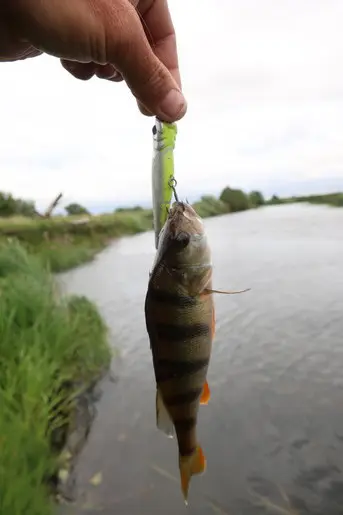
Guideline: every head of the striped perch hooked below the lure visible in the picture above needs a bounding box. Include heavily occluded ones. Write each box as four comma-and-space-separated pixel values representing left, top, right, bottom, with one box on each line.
159, 202, 211, 268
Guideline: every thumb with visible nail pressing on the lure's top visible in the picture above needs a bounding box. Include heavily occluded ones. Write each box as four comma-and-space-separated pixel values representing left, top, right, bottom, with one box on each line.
105, 0, 187, 122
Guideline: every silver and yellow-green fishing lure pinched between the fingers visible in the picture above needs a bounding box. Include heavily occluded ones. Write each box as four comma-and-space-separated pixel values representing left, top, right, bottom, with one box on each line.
152, 118, 177, 249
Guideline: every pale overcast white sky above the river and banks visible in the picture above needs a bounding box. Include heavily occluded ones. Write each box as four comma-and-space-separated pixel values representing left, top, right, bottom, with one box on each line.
0, 0, 343, 214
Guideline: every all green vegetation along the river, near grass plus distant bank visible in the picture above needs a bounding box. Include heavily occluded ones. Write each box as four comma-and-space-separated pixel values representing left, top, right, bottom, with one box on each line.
0, 188, 343, 515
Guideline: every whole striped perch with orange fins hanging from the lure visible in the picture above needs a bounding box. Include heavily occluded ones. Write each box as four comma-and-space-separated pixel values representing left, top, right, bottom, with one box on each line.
145, 201, 250, 504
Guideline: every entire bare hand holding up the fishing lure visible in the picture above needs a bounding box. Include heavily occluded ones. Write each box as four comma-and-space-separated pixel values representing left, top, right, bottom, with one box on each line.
0, 0, 187, 122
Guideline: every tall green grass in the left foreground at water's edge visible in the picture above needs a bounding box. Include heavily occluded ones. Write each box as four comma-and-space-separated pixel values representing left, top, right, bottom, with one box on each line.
0, 242, 110, 515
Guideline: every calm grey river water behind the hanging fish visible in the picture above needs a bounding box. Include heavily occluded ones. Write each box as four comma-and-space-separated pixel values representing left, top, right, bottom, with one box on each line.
57, 205, 343, 515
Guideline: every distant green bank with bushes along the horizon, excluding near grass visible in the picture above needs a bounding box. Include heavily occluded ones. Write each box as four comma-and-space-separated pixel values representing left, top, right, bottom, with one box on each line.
0, 187, 343, 272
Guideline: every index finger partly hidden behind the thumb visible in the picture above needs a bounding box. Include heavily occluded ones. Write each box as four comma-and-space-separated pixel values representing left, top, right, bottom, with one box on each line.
137, 0, 181, 89
